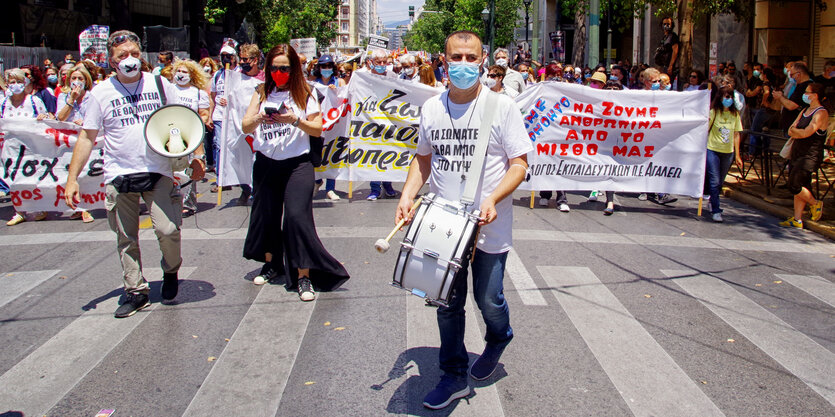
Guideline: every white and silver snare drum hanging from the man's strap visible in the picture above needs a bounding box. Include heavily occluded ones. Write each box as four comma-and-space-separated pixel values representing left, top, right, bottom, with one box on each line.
392, 193, 480, 306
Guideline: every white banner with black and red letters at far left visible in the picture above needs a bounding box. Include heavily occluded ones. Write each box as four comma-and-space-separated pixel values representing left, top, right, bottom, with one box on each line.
0, 118, 104, 212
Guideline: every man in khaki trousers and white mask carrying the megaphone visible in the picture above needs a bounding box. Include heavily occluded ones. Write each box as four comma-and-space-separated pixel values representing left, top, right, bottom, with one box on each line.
65, 30, 205, 318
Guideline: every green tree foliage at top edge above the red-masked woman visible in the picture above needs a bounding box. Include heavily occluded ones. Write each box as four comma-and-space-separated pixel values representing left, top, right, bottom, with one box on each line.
205, 0, 342, 48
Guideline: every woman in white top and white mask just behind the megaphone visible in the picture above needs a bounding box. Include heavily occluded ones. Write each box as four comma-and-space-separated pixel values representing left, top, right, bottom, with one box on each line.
160, 59, 214, 217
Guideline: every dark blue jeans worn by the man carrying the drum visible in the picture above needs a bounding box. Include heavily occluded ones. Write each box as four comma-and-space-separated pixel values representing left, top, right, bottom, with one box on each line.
438, 250, 513, 378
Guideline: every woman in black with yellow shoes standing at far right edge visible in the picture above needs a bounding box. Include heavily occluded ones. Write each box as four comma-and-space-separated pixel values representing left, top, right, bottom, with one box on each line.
780, 83, 830, 228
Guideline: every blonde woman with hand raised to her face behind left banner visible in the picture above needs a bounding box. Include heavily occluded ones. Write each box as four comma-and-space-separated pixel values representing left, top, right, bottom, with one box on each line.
55, 64, 93, 223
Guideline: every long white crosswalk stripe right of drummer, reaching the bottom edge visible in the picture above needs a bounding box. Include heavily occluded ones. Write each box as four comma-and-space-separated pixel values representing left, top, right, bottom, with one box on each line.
538, 266, 724, 417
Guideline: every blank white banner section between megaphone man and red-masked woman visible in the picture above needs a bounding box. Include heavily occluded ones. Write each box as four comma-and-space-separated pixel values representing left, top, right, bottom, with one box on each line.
215, 70, 258, 187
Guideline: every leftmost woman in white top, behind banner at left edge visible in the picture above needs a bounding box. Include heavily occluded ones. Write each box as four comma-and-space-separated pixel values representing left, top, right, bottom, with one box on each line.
0, 68, 51, 226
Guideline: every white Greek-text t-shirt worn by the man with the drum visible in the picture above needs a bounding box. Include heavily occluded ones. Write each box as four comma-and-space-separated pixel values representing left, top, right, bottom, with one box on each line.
417, 87, 533, 253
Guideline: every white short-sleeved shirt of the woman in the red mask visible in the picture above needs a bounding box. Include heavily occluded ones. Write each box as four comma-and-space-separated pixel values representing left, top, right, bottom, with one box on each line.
252, 91, 319, 161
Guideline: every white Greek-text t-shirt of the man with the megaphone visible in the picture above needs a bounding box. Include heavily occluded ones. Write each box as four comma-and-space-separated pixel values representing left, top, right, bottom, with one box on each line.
84, 72, 180, 183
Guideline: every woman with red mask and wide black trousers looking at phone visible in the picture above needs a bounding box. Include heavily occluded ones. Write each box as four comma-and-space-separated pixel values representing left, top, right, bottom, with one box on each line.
242, 44, 350, 301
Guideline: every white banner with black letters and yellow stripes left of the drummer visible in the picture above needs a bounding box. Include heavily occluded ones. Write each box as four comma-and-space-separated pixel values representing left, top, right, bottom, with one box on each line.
317, 72, 440, 181
